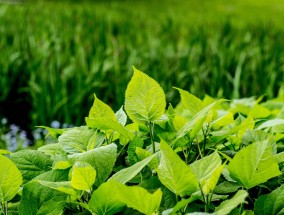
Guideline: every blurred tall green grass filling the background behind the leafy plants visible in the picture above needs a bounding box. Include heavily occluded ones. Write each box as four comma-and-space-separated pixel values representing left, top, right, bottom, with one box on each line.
0, 0, 284, 133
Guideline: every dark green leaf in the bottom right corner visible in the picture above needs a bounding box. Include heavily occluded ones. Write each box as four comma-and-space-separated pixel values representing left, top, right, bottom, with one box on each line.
254, 185, 284, 215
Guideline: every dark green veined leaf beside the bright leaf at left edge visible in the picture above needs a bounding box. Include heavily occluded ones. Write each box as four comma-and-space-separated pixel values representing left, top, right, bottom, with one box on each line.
11, 149, 53, 184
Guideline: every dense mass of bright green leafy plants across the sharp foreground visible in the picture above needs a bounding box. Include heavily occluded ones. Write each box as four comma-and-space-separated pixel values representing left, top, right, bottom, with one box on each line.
0, 68, 284, 215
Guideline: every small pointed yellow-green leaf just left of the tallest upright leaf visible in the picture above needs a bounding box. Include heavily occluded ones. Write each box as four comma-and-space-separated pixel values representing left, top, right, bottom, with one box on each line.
88, 95, 116, 120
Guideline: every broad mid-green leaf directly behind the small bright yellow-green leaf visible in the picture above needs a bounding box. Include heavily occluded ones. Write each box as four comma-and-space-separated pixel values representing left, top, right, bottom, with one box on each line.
68, 143, 117, 186
